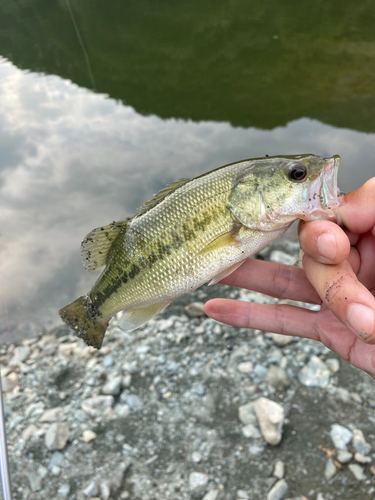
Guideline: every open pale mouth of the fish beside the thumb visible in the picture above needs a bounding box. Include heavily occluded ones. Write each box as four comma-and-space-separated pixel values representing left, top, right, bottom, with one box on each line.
309, 155, 342, 220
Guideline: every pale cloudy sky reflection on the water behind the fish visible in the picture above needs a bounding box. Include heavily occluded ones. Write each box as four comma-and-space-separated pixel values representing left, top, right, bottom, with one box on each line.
0, 60, 375, 341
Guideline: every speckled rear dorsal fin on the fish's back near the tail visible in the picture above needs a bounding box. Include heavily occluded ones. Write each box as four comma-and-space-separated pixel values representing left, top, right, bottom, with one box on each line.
81, 219, 130, 271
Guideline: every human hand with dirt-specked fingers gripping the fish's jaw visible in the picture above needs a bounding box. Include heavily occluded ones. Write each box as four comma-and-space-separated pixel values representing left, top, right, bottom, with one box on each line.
205, 178, 375, 378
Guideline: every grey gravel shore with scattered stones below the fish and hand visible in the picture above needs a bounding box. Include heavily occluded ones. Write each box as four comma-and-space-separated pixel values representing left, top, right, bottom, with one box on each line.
0, 241, 375, 500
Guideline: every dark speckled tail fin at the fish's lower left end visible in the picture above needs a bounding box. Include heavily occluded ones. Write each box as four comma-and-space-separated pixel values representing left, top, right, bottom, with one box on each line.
59, 297, 108, 349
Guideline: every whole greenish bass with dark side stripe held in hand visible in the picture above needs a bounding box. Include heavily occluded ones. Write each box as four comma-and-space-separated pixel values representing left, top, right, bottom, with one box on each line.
59, 154, 340, 349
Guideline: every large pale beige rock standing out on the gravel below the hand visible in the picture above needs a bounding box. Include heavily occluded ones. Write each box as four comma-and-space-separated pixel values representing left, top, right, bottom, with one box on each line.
255, 398, 284, 446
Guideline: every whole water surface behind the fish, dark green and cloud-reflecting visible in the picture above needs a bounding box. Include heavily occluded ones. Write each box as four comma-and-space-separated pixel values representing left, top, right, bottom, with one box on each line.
0, 0, 375, 340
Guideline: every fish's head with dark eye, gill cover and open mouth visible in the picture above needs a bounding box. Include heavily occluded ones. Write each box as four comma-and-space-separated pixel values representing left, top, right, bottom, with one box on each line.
229, 154, 341, 231
